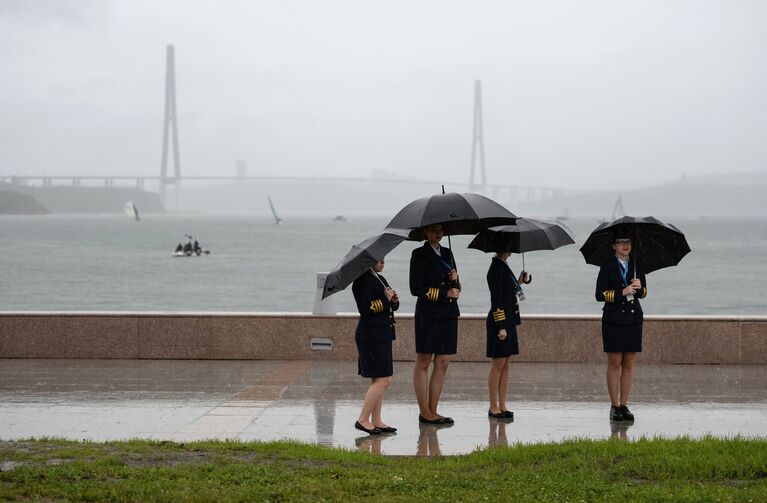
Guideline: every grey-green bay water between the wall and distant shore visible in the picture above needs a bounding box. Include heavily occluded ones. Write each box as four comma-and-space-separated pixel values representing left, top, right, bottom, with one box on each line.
0, 213, 767, 315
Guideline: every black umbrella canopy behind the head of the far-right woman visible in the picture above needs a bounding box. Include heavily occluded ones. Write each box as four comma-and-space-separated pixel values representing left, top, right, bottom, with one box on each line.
581, 216, 690, 273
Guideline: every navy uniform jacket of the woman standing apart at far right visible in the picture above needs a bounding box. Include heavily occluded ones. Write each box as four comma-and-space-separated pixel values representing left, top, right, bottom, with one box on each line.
595, 257, 647, 325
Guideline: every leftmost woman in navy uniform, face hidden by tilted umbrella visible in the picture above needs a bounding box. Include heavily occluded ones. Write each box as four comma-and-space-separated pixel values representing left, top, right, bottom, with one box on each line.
352, 259, 399, 435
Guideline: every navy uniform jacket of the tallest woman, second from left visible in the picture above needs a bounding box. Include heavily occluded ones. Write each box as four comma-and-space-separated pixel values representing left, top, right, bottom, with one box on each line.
410, 241, 461, 319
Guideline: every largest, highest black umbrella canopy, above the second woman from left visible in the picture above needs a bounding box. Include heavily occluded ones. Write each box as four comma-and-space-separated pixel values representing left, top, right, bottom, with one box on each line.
387, 192, 517, 241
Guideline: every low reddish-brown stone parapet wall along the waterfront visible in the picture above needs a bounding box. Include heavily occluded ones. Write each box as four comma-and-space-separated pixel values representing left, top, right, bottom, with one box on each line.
0, 312, 767, 364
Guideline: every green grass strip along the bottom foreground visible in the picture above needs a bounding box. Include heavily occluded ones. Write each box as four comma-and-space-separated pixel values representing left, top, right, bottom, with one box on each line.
0, 438, 767, 502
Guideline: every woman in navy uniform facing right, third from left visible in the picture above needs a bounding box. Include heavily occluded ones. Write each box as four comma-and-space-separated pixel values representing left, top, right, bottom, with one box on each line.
485, 252, 529, 419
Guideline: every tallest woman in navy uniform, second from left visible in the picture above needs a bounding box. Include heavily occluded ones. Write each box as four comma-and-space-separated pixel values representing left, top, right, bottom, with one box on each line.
410, 224, 461, 424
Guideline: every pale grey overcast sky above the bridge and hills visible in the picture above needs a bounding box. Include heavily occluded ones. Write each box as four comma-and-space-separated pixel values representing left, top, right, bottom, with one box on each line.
0, 0, 767, 188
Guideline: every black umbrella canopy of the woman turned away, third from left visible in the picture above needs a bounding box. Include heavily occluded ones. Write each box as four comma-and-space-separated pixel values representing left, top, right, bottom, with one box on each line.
469, 218, 575, 253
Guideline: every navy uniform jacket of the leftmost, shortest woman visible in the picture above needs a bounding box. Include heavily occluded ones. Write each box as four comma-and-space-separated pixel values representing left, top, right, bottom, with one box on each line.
352, 270, 399, 342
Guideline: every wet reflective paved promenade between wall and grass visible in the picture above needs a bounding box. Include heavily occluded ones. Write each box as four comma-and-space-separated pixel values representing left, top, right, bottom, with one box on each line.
0, 360, 767, 455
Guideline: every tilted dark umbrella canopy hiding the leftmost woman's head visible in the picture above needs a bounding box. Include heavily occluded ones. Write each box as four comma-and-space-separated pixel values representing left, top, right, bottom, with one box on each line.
322, 229, 410, 299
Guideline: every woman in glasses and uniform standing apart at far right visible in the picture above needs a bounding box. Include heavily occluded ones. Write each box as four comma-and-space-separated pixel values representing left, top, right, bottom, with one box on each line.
595, 237, 647, 421
